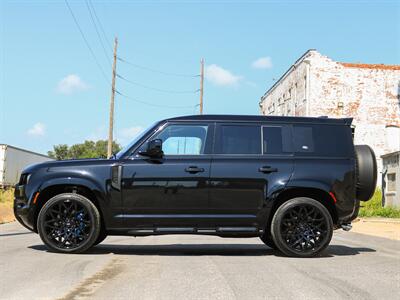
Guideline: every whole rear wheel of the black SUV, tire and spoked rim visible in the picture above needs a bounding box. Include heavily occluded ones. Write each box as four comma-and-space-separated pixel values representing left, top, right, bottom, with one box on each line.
271, 197, 333, 257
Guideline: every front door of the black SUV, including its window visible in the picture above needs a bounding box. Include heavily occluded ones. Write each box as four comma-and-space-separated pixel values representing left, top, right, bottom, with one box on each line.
122, 123, 213, 228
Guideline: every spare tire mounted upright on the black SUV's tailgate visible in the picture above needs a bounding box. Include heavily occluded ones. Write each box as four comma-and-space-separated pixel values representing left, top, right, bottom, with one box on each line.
354, 145, 378, 201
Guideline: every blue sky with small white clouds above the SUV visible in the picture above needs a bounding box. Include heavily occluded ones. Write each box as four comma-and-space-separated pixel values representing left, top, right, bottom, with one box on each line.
0, 0, 400, 153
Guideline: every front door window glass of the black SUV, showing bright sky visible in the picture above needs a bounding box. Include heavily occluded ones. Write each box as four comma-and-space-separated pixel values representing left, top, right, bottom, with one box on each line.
153, 125, 208, 155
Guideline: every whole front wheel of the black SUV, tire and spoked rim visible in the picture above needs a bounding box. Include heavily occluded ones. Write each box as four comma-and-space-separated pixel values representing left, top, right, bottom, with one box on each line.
37, 193, 101, 253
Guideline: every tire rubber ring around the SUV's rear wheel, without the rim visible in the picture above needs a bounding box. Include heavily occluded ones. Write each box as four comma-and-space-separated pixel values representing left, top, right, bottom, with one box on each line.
271, 197, 333, 257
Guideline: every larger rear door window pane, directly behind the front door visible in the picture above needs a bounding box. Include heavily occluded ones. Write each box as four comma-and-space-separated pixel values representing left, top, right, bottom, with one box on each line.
216, 125, 261, 154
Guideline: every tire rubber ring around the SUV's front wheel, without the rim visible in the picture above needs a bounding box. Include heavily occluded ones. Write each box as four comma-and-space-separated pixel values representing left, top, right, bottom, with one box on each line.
37, 193, 101, 253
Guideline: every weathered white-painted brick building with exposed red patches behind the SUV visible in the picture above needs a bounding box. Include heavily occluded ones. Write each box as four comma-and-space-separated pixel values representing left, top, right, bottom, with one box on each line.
260, 50, 400, 183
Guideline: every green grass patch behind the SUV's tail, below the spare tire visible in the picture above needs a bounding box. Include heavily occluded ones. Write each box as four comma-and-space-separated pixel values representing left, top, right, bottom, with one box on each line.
358, 189, 400, 218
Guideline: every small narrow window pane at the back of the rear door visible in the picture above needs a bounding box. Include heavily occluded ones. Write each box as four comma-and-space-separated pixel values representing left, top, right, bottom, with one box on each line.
262, 125, 291, 154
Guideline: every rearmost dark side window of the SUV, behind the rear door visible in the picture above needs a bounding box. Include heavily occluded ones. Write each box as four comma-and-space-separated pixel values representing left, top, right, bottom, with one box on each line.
293, 125, 353, 157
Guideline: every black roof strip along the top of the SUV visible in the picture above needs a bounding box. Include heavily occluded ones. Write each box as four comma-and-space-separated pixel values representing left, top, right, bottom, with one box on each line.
167, 115, 353, 125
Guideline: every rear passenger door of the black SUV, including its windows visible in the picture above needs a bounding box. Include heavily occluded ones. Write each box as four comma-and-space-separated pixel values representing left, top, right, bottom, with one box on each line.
210, 123, 293, 227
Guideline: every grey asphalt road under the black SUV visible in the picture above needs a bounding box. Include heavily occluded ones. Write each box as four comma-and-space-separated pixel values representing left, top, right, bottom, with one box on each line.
0, 222, 400, 300
